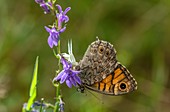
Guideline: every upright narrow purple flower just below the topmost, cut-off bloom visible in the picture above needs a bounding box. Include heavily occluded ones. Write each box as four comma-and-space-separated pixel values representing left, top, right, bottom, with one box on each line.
56, 4, 71, 29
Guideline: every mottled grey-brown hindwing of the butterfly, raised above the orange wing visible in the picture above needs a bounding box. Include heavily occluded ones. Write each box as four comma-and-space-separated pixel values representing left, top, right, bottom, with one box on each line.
77, 40, 117, 85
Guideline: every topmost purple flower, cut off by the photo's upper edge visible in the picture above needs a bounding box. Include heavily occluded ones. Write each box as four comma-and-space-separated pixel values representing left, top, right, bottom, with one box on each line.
35, 0, 52, 14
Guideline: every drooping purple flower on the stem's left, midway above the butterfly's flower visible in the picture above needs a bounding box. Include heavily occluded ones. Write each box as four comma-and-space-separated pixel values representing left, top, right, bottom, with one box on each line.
45, 26, 66, 48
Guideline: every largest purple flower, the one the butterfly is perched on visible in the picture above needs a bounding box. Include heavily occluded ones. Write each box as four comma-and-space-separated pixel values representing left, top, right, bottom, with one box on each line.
53, 57, 81, 88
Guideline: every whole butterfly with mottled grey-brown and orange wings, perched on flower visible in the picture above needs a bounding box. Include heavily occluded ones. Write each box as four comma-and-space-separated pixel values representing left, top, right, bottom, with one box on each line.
76, 39, 137, 95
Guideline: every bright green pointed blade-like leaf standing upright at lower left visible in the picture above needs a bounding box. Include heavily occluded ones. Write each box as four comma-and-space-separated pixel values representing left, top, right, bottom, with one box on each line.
26, 56, 39, 111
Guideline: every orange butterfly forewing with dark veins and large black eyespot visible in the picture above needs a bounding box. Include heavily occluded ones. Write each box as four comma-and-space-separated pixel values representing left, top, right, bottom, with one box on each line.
85, 63, 137, 95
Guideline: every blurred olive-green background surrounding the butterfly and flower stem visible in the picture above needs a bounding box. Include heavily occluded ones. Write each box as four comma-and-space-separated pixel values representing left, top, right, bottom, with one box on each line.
0, 0, 170, 112
